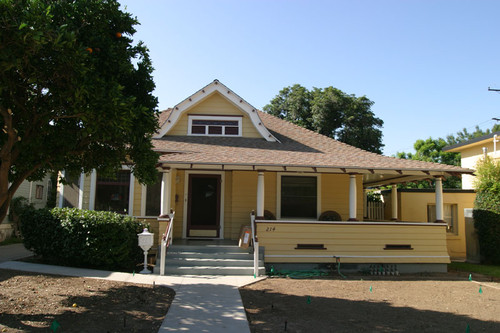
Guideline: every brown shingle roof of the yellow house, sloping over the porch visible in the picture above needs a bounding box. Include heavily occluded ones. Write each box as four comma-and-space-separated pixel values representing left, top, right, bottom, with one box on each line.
153, 109, 472, 173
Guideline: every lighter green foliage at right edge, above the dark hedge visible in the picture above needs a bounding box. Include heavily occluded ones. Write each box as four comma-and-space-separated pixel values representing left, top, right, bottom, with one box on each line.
474, 157, 500, 214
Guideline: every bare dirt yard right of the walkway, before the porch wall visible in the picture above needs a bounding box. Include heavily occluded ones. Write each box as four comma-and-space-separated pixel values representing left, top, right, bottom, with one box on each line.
240, 275, 500, 333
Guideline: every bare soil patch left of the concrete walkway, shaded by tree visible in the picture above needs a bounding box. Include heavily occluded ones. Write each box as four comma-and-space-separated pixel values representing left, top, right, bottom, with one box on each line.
0, 269, 175, 333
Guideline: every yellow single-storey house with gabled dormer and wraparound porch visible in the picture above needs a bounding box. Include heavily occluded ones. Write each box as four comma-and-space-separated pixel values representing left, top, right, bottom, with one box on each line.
59, 80, 472, 271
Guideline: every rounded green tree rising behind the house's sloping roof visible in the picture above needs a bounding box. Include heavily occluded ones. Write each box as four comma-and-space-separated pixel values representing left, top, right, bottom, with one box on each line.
264, 84, 384, 154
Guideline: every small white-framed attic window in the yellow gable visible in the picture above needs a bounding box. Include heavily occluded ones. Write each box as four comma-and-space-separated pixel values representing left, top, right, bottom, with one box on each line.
188, 116, 241, 136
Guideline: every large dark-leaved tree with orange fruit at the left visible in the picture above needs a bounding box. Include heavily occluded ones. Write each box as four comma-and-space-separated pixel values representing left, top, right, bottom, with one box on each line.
0, 0, 158, 221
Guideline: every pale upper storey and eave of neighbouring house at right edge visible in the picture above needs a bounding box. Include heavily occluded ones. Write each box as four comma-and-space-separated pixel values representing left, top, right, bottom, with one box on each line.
443, 132, 500, 190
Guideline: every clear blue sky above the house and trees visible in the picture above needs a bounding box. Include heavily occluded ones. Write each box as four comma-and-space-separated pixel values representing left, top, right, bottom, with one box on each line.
120, 0, 500, 155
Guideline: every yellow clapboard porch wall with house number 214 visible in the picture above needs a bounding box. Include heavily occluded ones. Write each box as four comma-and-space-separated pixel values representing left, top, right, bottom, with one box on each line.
256, 220, 450, 264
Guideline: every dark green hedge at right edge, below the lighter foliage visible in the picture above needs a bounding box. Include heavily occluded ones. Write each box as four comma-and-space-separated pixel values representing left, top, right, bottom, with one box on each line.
473, 209, 500, 264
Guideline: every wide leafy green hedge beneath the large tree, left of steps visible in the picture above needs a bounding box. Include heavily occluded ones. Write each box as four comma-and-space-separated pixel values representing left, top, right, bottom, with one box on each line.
20, 208, 146, 270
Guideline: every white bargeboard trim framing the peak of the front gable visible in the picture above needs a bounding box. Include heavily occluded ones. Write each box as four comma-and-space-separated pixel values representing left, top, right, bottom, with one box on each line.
155, 80, 277, 142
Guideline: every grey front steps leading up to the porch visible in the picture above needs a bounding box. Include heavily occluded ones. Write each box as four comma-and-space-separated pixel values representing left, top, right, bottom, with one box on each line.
154, 241, 266, 276
